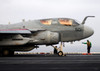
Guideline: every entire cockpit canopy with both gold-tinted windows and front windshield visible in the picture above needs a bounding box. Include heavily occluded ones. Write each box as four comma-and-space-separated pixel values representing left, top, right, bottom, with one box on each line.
40, 18, 79, 26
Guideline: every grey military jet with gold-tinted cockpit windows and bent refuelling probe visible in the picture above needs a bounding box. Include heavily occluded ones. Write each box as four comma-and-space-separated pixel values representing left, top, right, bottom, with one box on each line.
0, 16, 94, 56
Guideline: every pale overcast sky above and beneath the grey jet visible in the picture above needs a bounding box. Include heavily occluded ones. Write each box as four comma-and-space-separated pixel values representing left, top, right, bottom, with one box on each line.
0, 0, 100, 52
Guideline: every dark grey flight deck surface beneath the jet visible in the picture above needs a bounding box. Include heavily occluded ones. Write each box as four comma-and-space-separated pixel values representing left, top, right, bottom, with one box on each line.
0, 54, 100, 71
